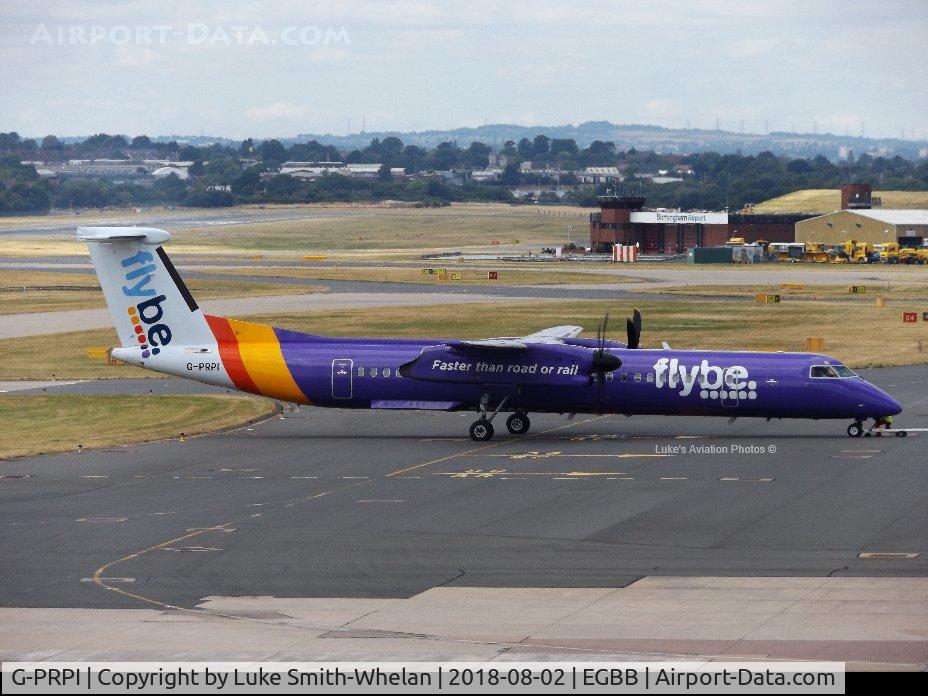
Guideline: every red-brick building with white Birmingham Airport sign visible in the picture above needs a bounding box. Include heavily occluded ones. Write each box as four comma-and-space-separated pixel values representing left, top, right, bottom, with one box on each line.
590, 195, 811, 254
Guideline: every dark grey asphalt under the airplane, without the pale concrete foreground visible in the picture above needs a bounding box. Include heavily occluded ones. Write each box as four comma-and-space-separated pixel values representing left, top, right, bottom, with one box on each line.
0, 367, 928, 607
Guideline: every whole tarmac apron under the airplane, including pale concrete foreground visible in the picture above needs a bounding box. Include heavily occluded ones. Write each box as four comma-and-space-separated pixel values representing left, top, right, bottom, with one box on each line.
0, 366, 928, 669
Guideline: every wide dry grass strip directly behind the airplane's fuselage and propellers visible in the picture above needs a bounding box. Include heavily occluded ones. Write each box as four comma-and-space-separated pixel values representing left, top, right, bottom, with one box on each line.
0, 296, 928, 380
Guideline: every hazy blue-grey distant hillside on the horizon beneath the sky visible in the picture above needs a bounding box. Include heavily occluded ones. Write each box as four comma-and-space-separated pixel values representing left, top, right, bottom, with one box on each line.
284, 121, 928, 160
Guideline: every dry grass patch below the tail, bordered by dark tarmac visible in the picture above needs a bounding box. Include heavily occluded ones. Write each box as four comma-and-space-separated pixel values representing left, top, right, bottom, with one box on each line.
0, 394, 274, 459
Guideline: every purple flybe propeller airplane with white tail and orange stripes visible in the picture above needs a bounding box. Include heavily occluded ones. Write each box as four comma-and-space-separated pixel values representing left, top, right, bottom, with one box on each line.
83, 227, 902, 441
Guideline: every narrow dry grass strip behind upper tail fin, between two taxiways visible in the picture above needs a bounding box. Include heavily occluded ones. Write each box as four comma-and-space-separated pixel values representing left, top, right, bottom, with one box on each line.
0, 271, 325, 314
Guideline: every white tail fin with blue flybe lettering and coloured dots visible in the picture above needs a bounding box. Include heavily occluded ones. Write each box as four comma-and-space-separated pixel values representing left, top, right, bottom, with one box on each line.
77, 227, 215, 358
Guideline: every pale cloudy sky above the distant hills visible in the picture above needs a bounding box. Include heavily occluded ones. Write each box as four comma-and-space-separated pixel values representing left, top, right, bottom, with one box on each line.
0, 0, 928, 138
